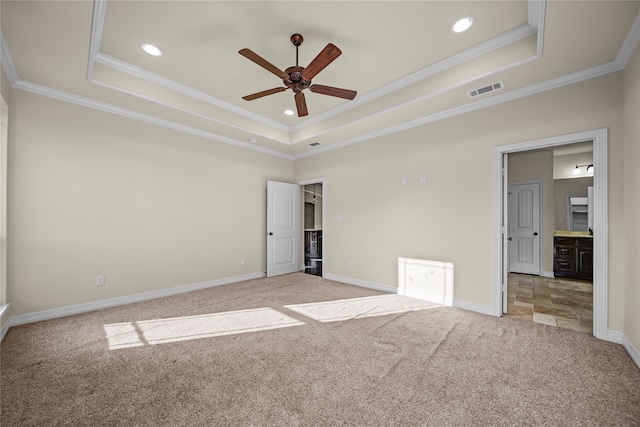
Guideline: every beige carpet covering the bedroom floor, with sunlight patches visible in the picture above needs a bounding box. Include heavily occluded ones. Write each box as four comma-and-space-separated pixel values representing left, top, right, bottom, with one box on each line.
0, 273, 640, 427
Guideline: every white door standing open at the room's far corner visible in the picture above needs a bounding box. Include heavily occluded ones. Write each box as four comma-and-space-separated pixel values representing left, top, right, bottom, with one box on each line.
267, 181, 300, 277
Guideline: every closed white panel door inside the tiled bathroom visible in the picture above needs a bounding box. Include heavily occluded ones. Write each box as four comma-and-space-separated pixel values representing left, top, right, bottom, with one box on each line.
508, 183, 540, 275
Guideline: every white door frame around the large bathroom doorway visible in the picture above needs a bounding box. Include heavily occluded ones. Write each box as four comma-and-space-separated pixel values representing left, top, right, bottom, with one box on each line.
493, 128, 609, 340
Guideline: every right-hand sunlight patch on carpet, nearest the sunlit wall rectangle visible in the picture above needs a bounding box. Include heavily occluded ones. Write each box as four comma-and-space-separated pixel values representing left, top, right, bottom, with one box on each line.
285, 295, 442, 322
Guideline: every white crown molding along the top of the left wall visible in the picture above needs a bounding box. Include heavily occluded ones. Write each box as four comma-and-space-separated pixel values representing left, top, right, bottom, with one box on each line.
13, 80, 293, 160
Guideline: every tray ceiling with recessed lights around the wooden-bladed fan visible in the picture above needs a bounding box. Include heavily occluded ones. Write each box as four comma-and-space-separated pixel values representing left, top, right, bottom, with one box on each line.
0, 0, 640, 158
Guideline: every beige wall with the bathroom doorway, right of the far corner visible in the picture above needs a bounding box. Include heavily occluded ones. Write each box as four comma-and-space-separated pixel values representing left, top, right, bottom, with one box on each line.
295, 73, 624, 331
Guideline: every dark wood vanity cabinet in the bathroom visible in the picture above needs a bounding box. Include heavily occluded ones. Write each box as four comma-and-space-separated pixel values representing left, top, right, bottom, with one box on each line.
553, 236, 593, 280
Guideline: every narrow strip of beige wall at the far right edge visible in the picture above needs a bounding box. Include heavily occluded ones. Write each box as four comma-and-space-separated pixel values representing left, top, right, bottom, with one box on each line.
621, 48, 640, 351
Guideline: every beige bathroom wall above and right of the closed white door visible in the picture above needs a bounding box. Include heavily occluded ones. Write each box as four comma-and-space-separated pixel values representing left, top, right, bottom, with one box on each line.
508, 150, 555, 276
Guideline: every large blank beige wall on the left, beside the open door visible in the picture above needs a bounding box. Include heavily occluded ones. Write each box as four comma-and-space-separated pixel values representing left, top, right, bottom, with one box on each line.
7, 91, 293, 315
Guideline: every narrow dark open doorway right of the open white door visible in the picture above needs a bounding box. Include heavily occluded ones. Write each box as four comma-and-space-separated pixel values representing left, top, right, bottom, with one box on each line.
302, 182, 324, 276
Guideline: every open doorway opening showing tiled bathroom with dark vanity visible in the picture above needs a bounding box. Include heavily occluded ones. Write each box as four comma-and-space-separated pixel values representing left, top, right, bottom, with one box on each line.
503, 145, 593, 334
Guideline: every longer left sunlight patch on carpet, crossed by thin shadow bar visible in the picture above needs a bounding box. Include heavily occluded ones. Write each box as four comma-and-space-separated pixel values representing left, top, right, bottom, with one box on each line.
104, 308, 304, 350
